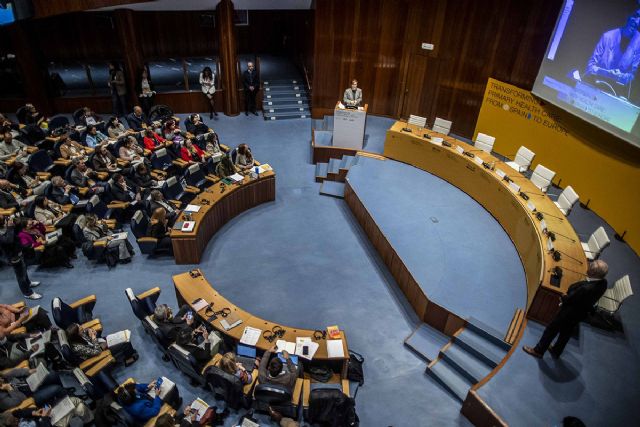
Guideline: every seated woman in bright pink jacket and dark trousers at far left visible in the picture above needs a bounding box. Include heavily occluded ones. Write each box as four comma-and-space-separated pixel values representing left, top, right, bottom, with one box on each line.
16, 218, 76, 268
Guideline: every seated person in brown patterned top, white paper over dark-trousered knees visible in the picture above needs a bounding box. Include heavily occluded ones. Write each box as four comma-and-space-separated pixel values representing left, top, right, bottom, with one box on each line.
66, 323, 138, 366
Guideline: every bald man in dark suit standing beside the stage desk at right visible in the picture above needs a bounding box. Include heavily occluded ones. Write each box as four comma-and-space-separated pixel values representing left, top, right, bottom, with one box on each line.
522, 260, 609, 359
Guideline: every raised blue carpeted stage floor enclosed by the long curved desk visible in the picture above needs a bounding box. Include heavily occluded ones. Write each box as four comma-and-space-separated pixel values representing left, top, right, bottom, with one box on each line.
347, 157, 527, 335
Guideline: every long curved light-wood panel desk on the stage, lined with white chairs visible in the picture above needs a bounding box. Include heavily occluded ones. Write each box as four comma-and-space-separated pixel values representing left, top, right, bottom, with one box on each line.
370, 121, 587, 323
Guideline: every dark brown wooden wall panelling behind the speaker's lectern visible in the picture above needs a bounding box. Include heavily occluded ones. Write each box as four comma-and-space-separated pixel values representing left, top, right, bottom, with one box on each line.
313, 0, 562, 137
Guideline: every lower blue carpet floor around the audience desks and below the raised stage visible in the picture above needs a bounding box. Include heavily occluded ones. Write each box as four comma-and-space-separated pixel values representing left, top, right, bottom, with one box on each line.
0, 115, 640, 427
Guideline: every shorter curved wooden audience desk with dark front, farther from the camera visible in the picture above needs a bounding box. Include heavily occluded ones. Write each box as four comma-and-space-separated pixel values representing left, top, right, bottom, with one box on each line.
171, 171, 276, 264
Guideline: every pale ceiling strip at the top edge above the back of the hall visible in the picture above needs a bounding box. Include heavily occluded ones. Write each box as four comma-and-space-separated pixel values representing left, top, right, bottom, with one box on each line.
93, 0, 312, 12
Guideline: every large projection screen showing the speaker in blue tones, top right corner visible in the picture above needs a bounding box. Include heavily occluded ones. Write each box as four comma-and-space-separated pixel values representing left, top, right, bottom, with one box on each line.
532, 0, 640, 145
